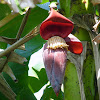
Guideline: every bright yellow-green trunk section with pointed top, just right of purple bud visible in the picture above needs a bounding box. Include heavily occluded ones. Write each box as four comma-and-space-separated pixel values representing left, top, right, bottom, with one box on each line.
64, 61, 81, 100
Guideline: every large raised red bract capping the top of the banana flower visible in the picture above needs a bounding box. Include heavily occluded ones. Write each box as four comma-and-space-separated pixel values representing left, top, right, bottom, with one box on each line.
40, 8, 73, 40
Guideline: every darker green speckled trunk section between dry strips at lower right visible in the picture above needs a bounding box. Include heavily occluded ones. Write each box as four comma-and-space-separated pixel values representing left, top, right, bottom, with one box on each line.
83, 46, 99, 100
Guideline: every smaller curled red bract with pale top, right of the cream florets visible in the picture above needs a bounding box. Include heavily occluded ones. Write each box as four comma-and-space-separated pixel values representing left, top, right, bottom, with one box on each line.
65, 34, 83, 54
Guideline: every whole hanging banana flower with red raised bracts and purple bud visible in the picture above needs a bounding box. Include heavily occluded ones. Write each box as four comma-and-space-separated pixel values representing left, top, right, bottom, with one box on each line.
40, 8, 83, 95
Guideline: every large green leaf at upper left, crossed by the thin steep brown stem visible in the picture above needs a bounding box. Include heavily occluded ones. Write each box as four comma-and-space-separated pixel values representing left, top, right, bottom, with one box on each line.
0, 7, 48, 38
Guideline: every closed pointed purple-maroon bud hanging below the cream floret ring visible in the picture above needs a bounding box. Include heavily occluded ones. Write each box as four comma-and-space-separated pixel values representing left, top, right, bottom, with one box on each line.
43, 43, 67, 96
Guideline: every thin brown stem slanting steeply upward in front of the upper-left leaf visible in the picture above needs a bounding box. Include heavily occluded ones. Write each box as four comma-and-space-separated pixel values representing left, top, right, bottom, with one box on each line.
16, 8, 31, 40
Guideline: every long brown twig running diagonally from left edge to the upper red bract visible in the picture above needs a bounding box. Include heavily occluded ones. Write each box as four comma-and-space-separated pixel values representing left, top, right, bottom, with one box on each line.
0, 25, 40, 57
